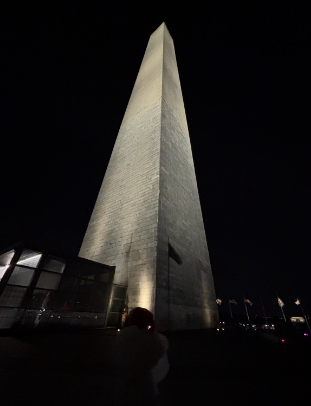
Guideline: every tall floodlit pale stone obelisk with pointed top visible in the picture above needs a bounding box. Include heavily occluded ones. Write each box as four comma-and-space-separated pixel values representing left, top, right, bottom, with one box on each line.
79, 23, 218, 330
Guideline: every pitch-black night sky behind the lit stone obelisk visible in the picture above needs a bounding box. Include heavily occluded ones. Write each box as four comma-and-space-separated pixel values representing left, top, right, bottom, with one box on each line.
0, 1, 311, 316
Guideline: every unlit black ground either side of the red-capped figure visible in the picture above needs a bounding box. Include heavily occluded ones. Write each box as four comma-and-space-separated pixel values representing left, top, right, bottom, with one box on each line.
0, 328, 311, 406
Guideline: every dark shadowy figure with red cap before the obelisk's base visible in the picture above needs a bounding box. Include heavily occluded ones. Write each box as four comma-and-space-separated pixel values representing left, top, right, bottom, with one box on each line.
114, 307, 169, 406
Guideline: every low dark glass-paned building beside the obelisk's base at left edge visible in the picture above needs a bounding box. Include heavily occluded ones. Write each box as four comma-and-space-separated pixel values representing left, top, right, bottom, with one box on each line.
0, 243, 126, 329
